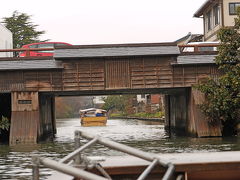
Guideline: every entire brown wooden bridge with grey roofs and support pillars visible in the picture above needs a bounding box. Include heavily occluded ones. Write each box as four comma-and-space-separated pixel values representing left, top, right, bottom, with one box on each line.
0, 43, 221, 144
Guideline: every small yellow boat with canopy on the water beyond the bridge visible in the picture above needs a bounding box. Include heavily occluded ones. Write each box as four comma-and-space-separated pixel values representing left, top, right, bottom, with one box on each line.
79, 108, 107, 126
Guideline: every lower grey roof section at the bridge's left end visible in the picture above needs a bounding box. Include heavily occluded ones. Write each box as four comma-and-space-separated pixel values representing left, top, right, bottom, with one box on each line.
0, 60, 62, 71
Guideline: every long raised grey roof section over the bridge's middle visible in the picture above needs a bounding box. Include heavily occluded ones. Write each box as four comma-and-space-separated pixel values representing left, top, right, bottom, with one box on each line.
54, 43, 180, 60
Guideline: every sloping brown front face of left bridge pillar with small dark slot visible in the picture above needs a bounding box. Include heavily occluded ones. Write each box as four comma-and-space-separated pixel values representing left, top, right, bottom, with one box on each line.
9, 92, 39, 144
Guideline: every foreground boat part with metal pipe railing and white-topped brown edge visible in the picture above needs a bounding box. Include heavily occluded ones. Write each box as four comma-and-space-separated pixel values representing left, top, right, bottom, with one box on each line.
33, 131, 240, 180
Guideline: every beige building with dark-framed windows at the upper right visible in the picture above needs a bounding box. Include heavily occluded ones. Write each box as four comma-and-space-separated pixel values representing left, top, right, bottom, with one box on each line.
194, 0, 240, 41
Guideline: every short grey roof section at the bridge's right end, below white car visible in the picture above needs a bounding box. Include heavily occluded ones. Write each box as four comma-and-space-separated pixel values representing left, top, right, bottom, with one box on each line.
173, 54, 216, 65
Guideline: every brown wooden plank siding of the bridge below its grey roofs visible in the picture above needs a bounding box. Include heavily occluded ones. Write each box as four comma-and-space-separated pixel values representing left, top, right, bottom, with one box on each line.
0, 56, 221, 92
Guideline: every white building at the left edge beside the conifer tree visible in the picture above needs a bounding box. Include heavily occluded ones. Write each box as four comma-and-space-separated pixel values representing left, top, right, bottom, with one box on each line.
0, 23, 13, 57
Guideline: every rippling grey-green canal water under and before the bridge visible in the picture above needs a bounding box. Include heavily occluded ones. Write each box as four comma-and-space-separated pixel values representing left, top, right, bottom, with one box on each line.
0, 118, 240, 180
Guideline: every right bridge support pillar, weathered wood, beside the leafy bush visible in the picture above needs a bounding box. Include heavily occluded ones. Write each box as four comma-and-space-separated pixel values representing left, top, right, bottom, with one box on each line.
164, 88, 222, 137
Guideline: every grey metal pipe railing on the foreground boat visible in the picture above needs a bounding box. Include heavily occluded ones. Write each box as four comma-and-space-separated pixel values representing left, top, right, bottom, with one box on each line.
33, 131, 175, 180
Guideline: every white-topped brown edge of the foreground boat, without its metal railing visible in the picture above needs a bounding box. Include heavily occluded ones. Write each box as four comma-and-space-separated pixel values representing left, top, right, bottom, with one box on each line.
81, 151, 240, 180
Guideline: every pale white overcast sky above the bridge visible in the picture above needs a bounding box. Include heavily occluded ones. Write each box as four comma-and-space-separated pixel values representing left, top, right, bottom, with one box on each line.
0, 0, 205, 45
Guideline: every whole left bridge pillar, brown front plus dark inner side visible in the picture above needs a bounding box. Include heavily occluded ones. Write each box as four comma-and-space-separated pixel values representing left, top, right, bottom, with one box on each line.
9, 92, 56, 144
